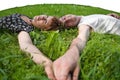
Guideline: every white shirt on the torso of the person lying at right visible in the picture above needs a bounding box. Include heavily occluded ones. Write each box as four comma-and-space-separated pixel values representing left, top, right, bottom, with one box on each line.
79, 14, 120, 35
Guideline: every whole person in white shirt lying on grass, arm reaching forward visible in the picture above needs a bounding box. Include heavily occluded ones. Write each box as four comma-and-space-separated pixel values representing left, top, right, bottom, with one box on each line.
50, 13, 120, 80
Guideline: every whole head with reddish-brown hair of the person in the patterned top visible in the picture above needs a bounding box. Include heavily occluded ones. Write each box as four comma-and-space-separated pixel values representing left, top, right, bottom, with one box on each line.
32, 15, 59, 30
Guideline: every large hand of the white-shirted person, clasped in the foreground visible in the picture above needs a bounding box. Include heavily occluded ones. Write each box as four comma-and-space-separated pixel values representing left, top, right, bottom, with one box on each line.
53, 54, 80, 80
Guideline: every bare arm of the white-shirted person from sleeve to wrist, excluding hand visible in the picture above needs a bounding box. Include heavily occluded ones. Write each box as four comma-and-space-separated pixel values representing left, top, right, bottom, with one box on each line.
66, 25, 90, 56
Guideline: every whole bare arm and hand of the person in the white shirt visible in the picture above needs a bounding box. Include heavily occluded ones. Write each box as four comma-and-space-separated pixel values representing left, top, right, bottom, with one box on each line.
53, 25, 90, 80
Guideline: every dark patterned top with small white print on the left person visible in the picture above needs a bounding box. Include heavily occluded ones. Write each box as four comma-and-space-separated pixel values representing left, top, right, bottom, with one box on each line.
0, 13, 33, 33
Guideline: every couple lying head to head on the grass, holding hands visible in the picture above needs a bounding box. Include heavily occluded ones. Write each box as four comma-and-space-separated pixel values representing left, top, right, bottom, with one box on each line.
0, 13, 120, 80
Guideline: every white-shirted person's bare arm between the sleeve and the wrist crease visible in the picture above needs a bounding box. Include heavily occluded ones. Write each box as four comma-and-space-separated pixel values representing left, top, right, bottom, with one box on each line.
70, 25, 90, 54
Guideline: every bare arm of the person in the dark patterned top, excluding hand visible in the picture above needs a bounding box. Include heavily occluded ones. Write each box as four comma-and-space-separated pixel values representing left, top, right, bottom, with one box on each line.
18, 31, 49, 65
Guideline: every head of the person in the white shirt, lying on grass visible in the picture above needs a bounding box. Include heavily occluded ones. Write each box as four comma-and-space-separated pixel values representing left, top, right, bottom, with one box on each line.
59, 14, 80, 28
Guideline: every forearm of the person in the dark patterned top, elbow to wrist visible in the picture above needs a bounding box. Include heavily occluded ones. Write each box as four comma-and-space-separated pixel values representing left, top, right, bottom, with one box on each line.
20, 44, 47, 64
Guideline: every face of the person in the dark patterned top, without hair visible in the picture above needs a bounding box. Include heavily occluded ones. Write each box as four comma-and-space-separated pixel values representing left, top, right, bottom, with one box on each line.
32, 15, 54, 30
